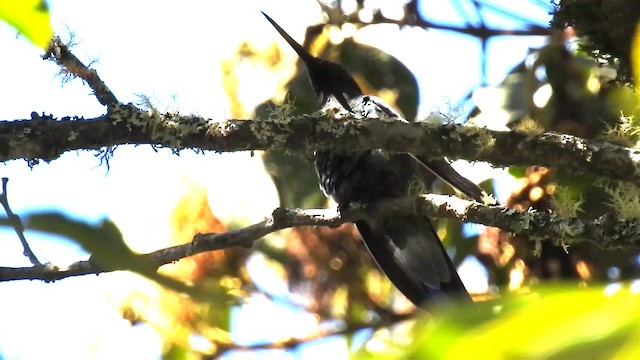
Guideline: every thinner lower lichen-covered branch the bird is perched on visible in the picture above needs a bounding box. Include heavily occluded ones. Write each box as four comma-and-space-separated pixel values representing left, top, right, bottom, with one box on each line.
0, 194, 640, 282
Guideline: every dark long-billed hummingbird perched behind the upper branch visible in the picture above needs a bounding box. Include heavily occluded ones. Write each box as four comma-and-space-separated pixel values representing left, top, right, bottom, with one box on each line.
263, 12, 487, 306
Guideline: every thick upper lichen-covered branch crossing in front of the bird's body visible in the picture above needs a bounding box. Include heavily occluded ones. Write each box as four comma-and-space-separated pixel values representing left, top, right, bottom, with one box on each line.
0, 104, 640, 183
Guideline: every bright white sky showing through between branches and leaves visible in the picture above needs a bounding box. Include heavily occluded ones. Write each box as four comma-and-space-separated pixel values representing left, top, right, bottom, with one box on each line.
0, 0, 548, 359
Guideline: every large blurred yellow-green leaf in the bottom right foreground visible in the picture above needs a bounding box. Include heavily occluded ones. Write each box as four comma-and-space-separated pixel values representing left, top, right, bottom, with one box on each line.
354, 283, 640, 359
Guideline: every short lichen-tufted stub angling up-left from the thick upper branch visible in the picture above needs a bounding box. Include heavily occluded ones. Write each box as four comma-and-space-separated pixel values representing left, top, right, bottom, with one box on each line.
42, 36, 118, 107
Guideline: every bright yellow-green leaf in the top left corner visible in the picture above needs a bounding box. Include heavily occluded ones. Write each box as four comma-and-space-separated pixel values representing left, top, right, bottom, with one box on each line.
0, 0, 53, 49
